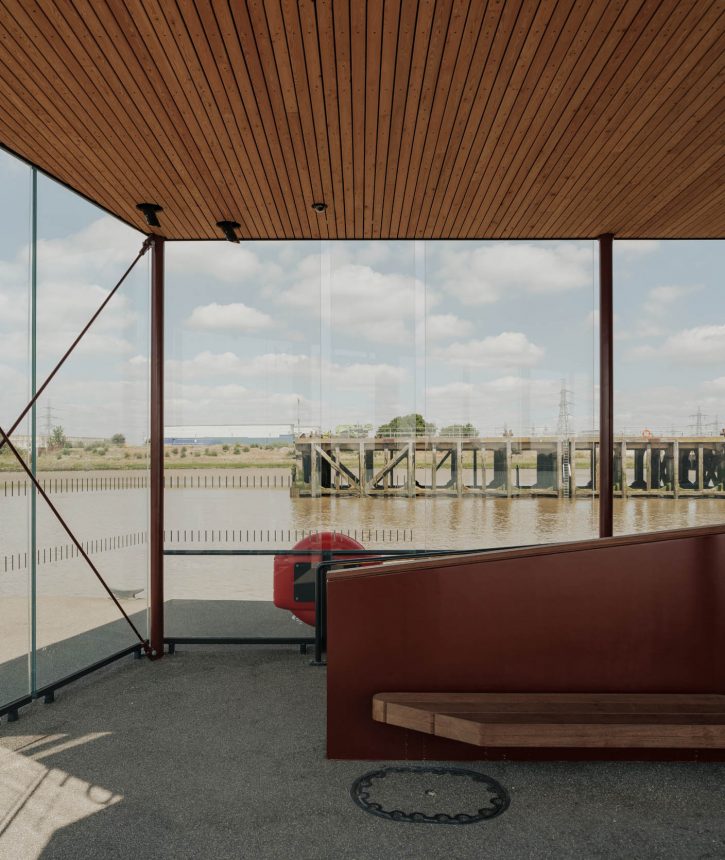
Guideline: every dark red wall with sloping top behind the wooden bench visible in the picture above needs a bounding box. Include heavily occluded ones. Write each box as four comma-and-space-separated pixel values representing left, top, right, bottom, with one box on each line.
327, 528, 725, 760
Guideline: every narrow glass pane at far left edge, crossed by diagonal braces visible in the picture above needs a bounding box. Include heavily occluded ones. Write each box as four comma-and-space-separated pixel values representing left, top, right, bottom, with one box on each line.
0, 150, 31, 706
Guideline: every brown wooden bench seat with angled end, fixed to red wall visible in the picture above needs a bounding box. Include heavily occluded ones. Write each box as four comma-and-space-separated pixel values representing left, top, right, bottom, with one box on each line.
373, 693, 725, 749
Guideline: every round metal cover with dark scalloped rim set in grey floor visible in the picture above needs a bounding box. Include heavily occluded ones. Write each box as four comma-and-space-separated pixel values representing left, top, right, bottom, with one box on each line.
350, 767, 509, 824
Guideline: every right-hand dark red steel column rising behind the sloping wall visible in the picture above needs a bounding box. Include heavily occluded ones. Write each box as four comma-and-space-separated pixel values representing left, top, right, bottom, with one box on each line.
599, 233, 614, 537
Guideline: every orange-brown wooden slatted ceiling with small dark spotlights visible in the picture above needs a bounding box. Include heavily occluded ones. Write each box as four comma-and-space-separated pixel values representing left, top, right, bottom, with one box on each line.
0, 0, 725, 239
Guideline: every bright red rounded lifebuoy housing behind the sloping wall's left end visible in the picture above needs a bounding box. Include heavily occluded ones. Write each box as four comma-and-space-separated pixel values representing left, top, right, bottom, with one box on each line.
273, 532, 365, 627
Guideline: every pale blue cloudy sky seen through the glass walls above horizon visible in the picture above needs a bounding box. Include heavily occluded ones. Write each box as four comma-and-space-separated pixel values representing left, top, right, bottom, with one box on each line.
0, 147, 725, 439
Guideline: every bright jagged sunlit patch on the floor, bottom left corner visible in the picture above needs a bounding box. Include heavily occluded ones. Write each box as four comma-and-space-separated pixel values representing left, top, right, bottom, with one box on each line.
0, 732, 123, 860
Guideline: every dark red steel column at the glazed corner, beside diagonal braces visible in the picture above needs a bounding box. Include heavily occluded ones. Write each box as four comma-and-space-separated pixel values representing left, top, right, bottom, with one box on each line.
149, 236, 164, 657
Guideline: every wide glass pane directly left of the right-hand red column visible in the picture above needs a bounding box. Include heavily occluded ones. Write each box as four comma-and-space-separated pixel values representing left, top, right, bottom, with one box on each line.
423, 241, 598, 549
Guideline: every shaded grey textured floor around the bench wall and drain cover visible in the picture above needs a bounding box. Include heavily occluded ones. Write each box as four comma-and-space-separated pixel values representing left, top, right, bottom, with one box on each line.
0, 647, 725, 860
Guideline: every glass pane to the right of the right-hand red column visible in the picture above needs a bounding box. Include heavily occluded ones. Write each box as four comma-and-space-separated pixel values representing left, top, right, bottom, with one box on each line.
614, 235, 725, 534
